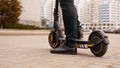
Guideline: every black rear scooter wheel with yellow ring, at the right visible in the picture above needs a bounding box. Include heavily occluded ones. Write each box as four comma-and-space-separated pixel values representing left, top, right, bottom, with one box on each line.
89, 32, 108, 57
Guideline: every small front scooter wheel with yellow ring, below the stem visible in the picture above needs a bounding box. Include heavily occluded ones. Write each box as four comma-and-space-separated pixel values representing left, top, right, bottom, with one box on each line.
48, 32, 60, 49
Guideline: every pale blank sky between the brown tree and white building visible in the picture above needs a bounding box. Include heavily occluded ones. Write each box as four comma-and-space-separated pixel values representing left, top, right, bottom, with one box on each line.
20, 0, 40, 21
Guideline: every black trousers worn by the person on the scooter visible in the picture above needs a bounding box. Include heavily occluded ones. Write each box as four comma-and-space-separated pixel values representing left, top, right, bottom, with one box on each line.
60, 0, 80, 47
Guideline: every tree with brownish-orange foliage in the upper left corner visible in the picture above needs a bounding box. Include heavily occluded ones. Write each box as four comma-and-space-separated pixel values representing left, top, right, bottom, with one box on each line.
0, 0, 22, 25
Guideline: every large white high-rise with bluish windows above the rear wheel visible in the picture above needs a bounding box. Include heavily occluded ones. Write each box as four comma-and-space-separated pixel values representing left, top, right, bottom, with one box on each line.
83, 0, 120, 30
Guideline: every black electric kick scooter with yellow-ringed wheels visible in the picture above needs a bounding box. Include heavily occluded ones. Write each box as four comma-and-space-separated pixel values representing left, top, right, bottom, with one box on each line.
48, 0, 109, 57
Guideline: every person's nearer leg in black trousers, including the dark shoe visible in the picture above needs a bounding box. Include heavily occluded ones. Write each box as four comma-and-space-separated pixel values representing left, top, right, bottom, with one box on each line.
51, 0, 80, 54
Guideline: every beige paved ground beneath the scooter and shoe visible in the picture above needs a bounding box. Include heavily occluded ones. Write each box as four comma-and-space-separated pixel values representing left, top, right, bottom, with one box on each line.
0, 30, 120, 68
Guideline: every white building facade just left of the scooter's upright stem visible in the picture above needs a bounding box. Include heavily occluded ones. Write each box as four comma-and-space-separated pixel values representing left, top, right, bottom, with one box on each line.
41, 0, 55, 22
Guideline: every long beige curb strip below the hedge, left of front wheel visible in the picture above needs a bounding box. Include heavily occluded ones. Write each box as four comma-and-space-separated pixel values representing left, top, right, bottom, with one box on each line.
0, 29, 50, 36
